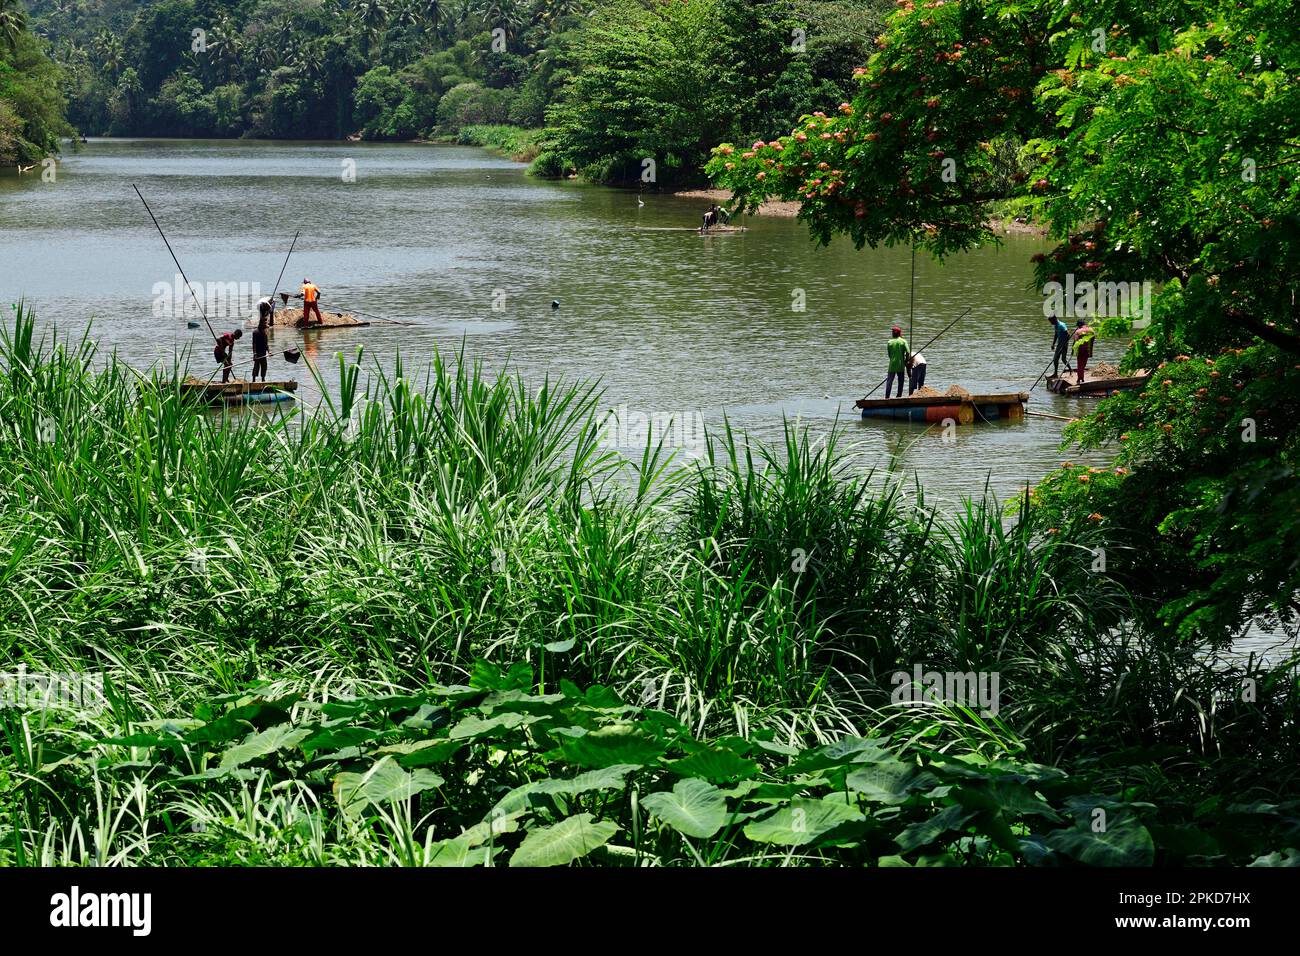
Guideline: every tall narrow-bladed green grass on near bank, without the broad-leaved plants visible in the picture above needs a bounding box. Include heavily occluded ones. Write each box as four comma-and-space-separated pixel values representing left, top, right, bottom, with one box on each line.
0, 308, 1297, 862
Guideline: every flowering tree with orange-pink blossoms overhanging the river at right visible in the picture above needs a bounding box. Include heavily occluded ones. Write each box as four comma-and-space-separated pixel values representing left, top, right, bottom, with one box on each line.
709, 0, 1300, 636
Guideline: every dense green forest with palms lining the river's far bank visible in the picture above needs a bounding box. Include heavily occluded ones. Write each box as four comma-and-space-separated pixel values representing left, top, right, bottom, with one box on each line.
20, 0, 892, 183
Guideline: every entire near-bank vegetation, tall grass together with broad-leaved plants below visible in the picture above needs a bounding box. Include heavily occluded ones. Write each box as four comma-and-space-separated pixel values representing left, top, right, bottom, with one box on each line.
0, 308, 1300, 866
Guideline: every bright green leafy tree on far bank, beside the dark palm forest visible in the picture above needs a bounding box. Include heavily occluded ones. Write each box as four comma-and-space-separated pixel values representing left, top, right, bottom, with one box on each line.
547, 0, 855, 183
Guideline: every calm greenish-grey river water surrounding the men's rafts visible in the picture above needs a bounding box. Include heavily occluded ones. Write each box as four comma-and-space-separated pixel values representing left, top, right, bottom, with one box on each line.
0, 140, 1279, 658
